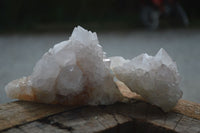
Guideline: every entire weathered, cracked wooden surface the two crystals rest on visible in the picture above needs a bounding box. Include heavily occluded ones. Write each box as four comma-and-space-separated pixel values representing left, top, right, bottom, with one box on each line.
0, 84, 200, 133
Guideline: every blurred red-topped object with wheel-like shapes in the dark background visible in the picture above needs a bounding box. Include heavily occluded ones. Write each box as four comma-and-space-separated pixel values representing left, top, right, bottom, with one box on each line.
140, 0, 189, 29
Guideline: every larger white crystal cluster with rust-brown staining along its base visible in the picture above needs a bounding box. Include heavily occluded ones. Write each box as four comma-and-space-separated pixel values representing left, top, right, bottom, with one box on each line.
5, 26, 121, 105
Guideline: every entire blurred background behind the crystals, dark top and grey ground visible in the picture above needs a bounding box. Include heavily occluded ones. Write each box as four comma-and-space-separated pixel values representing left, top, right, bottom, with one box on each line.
0, 0, 200, 103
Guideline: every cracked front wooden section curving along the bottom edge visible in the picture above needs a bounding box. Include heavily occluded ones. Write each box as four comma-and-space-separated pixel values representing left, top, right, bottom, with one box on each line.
3, 101, 200, 133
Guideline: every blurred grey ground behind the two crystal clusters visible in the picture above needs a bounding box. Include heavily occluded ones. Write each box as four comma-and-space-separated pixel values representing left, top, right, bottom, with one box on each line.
0, 29, 200, 103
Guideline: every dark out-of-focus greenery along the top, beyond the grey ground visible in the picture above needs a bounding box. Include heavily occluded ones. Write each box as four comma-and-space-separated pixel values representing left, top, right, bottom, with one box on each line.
0, 0, 200, 31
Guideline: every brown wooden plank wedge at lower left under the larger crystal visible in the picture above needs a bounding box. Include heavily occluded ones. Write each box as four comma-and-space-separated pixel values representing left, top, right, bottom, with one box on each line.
0, 101, 77, 131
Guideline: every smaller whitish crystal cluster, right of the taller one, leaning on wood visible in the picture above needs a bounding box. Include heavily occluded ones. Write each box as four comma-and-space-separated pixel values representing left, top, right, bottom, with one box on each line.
110, 49, 182, 111
